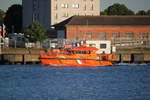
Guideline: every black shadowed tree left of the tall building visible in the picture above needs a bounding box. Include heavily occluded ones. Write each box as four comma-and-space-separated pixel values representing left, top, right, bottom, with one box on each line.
4, 4, 22, 33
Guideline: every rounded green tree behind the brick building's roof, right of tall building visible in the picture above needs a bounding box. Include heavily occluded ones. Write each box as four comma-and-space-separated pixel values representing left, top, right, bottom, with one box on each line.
104, 3, 134, 15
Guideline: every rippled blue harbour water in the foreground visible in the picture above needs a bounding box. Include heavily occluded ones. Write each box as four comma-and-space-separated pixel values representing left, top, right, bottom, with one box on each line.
0, 65, 150, 100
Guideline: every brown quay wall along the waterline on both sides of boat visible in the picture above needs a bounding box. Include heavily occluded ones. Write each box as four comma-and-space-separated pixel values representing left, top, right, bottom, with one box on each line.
0, 48, 150, 64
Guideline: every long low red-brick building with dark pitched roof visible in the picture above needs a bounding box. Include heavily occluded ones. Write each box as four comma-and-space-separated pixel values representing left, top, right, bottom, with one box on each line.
54, 16, 150, 40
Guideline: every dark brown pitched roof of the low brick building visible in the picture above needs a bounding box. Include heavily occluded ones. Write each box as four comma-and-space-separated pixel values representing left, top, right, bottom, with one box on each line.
54, 16, 150, 26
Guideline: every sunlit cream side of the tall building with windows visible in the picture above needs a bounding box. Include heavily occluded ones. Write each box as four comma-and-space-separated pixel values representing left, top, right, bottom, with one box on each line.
51, 0, 100, 24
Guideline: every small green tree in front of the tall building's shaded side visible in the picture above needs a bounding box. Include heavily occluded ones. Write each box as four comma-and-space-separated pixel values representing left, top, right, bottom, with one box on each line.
24, 22, 46, 42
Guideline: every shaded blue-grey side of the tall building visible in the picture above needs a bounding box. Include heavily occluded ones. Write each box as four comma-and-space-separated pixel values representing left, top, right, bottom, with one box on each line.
22, 0, 51, 29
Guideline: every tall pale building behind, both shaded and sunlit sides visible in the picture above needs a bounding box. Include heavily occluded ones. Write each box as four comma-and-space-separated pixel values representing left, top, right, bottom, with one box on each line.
22, 0, 100, 28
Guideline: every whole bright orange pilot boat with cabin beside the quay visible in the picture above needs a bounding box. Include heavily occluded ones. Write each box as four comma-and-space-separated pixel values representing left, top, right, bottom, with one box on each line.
40, 45, 112, 67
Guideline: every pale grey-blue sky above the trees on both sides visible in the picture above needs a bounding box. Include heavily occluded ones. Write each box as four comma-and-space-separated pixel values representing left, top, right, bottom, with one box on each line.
0, 0, 150, 12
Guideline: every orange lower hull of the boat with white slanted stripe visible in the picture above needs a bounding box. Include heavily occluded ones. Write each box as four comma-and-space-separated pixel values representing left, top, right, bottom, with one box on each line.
40, 58, 112, 67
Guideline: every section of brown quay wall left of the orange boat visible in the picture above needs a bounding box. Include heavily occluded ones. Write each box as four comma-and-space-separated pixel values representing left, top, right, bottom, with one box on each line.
0, 48, 43, 64
